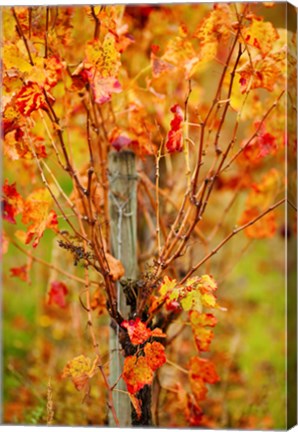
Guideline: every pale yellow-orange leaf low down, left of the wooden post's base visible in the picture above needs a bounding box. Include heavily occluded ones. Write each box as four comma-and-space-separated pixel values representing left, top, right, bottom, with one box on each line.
62, 355, 98, 391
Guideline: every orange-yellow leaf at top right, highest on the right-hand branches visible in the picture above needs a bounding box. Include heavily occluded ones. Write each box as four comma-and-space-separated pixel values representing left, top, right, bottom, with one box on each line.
242, 17, 279, 57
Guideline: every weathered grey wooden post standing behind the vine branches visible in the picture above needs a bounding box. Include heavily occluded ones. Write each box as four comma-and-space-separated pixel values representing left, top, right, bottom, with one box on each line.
109, 151, 138, 427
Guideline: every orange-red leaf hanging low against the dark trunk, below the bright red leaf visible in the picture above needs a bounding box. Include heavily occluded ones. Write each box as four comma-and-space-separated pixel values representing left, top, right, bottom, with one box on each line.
122, 356, 153, 394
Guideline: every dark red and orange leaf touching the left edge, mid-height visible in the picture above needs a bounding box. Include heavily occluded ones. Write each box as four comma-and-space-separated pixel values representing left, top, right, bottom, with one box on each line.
2, 179, 24, 224
